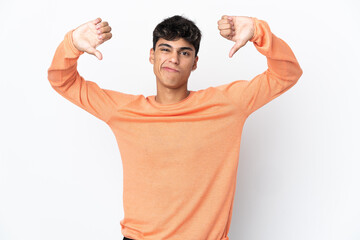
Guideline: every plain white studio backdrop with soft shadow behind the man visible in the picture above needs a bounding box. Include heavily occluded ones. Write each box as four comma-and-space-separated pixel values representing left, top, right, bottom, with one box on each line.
0, 0, 360, 240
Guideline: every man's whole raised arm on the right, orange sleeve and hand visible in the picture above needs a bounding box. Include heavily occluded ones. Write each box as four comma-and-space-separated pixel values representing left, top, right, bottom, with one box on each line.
218, 16, 302, 115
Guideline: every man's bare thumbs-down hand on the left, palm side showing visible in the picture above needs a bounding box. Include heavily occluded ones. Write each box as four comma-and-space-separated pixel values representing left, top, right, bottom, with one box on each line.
73, 18, 112, 60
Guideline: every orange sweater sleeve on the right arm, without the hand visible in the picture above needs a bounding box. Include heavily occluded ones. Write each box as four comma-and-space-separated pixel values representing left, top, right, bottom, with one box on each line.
218, 18, 302, 115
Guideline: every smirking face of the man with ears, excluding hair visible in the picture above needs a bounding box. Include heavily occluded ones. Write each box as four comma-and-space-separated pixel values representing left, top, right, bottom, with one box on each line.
150, 38, 198, 89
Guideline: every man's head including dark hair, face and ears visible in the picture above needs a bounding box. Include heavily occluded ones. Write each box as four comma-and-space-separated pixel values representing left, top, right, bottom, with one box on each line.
149, 16, 201, 90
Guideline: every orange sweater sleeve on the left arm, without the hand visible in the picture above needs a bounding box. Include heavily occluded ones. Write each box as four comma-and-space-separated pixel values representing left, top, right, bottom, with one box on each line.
48, 30, 133, 123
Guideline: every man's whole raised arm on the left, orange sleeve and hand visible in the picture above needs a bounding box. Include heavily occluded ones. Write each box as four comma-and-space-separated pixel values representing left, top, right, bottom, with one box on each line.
48, 18, 128, 122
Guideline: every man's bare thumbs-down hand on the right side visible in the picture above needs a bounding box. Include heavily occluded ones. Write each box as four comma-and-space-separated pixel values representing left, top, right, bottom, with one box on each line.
218, 15, 255, 57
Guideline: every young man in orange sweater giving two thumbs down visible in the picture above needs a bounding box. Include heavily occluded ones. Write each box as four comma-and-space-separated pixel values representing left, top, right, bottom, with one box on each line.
48, 16, 302, 240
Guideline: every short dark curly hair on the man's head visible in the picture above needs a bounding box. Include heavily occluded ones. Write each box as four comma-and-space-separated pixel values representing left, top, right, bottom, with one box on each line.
153, 15, 201, 56
